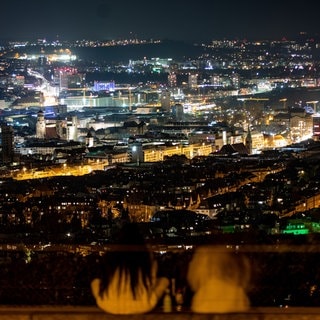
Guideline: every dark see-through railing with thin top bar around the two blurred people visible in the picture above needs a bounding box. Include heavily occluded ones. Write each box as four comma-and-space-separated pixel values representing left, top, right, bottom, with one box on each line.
0, 238, 320, 312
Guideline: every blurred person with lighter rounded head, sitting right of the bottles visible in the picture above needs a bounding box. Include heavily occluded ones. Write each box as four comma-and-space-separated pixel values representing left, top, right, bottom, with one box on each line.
187, 245, 250, 313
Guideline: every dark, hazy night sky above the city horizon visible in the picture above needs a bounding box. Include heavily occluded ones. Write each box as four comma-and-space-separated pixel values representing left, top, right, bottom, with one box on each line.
0, 0, 320, 42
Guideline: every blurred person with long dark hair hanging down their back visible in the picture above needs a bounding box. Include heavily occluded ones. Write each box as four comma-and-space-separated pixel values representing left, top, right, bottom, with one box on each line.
91, 222, 169, 314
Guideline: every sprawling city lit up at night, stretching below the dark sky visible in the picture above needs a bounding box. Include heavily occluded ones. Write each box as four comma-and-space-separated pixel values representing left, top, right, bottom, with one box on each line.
0, 4, 320, 318
